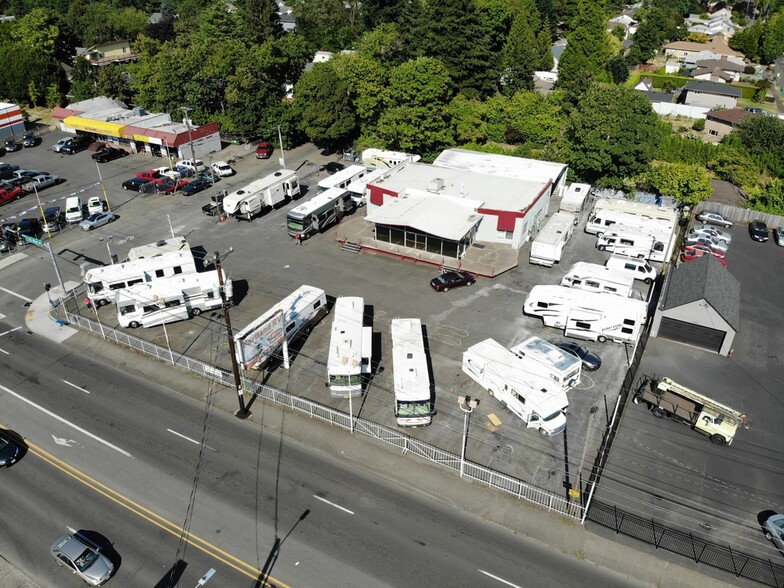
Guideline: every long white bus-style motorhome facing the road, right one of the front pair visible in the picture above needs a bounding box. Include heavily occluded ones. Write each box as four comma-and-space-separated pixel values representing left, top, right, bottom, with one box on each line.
391, 319, 433, 427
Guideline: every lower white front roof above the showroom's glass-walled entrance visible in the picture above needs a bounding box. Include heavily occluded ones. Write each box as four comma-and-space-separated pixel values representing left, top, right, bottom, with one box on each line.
366, 190, 482, 241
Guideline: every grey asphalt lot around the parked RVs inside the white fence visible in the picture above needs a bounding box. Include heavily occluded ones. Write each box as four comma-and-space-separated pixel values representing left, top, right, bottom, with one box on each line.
3, 135, 647, 504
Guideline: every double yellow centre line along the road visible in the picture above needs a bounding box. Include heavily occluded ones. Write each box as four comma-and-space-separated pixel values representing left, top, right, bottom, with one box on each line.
27, 441, 291, 588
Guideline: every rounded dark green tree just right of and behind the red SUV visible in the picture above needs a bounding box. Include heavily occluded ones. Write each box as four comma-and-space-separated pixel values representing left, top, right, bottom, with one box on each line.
294, 62, 357, 149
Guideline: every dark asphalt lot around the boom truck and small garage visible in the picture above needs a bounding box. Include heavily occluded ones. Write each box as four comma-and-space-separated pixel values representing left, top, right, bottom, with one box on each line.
597, 219, 784, 562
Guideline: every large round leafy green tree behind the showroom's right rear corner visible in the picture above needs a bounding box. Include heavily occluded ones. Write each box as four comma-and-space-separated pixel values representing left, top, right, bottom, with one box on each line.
565, 83, 659, 182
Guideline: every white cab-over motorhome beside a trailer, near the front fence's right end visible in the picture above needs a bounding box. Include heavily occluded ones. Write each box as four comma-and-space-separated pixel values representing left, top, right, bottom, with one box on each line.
463, 339, 569, 436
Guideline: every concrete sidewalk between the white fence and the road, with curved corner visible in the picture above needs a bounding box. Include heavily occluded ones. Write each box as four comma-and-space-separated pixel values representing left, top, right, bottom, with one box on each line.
18, 282, 751, 588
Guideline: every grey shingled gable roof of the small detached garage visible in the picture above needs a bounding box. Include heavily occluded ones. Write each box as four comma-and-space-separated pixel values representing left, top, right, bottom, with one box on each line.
662, 255, 740, 332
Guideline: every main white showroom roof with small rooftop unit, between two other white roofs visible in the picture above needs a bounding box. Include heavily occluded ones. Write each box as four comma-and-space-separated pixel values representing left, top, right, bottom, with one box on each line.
368, 163, 546, 211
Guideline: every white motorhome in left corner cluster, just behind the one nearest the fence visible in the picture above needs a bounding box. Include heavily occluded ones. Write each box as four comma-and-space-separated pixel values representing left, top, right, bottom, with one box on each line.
83, 249, 196, 306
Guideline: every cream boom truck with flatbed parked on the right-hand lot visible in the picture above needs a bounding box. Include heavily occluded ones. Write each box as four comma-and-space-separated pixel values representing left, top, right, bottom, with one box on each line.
634, 376, 750, 445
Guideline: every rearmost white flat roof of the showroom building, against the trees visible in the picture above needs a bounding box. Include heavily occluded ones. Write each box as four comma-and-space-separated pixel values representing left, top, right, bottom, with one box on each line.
433, 149, 568, 183
